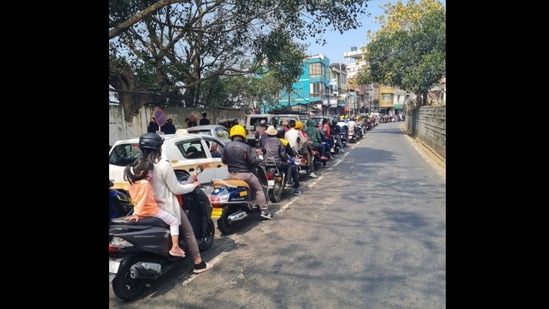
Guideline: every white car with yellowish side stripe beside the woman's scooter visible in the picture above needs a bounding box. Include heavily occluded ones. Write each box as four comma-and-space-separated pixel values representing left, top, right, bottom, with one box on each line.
109, 133, 229, 190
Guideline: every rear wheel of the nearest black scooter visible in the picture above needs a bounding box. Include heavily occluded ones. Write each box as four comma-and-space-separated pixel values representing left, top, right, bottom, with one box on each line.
112, 258, 147, 301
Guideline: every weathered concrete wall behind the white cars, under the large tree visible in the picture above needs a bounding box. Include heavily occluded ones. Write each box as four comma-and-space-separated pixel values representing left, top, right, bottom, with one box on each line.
109, 105, 246, 145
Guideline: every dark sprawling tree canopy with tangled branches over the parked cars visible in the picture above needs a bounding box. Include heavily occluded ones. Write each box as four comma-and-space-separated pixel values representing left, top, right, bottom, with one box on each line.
109, 0, 367, 116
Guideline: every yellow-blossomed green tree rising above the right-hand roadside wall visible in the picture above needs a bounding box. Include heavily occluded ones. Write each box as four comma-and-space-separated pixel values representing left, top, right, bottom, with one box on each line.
357, 0, 446, 105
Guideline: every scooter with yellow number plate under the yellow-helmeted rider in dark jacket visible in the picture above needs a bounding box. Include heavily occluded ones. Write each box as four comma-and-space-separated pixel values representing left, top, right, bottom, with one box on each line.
209, 165, 269, 235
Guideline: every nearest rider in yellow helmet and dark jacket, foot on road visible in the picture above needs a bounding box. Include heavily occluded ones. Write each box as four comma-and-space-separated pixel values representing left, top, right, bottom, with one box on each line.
221, 124, 273, 220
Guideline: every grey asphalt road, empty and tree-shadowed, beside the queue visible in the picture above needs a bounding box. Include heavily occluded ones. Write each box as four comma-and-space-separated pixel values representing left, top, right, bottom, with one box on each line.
109, 123, 446, 309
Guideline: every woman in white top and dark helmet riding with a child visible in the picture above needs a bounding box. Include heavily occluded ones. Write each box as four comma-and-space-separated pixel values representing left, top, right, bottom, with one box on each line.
139, 133, 214, 274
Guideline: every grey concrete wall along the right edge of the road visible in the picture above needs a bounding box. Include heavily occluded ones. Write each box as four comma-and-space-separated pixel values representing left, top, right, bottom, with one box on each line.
405, 105, 446, 159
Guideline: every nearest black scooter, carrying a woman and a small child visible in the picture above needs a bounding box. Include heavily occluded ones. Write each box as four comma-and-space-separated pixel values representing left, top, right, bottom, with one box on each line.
109, 166, 215, 301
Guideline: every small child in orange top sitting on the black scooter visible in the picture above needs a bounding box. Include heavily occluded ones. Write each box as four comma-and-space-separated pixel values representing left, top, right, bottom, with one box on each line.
124, 158, 185, 257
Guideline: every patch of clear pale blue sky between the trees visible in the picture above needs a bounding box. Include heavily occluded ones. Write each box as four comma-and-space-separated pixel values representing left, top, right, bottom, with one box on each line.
307, 0, 446, 63
